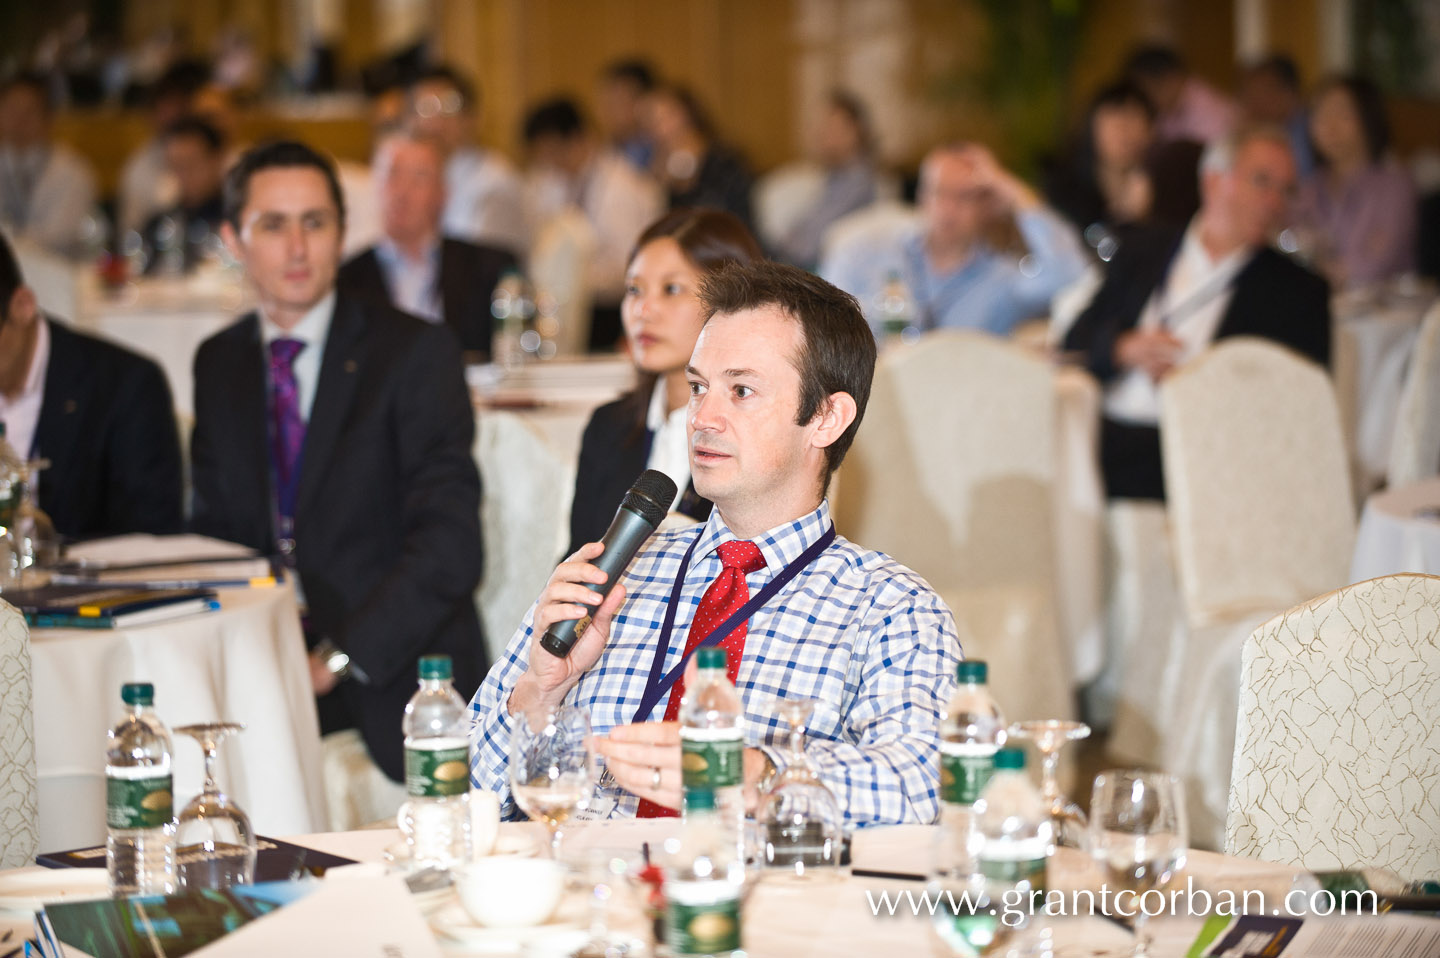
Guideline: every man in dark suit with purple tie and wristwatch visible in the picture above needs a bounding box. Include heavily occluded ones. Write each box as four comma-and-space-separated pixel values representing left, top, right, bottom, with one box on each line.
190, 143, 485, 800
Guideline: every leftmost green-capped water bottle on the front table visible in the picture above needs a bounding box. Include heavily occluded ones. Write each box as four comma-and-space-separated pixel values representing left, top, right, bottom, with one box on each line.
105, 681, 176, 895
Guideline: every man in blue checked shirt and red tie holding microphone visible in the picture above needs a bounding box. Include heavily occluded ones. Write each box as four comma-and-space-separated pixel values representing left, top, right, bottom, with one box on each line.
471, 264, 962, 824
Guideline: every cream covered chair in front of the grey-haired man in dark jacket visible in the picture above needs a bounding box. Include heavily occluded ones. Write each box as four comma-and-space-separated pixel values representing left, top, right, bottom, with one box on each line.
1116, 339, 1355, 847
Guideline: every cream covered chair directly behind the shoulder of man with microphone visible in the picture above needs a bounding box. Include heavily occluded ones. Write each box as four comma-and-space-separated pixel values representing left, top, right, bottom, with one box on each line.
834, 330, 1074, 719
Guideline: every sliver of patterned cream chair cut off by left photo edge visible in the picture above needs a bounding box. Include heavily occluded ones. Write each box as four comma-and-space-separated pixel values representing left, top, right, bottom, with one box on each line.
0, 602, 40, 869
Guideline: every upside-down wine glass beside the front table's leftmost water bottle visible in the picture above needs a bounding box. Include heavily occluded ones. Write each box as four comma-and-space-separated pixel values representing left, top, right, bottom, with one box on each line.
176, 722, 255, 889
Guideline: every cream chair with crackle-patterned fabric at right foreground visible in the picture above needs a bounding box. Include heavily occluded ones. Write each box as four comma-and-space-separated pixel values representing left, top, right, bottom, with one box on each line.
1225, 575, 1440, 879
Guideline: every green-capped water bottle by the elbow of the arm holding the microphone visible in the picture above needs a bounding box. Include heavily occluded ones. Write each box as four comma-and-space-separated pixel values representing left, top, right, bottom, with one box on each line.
400, 655, 469, 870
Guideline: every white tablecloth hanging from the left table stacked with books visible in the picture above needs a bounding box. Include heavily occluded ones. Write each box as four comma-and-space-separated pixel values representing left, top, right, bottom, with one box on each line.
30, 583, 325, 851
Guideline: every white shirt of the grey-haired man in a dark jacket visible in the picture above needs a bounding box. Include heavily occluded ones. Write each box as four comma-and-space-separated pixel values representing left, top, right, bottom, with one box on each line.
1104, 222, 1256, 425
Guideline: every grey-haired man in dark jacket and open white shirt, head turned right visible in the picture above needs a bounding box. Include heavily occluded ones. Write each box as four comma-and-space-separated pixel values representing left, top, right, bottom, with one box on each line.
1064, 127, 1331, 500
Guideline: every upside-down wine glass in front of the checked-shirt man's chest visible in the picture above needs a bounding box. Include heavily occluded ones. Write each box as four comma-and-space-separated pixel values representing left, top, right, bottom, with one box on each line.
755, 699, 845, 880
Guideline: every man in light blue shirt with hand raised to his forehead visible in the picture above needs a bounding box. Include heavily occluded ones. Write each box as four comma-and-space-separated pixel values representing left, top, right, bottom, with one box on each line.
819, 144, 1087, 336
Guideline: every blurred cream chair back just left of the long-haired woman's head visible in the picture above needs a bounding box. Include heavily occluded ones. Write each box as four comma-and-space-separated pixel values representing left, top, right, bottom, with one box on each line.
530, 207, 599, 356
